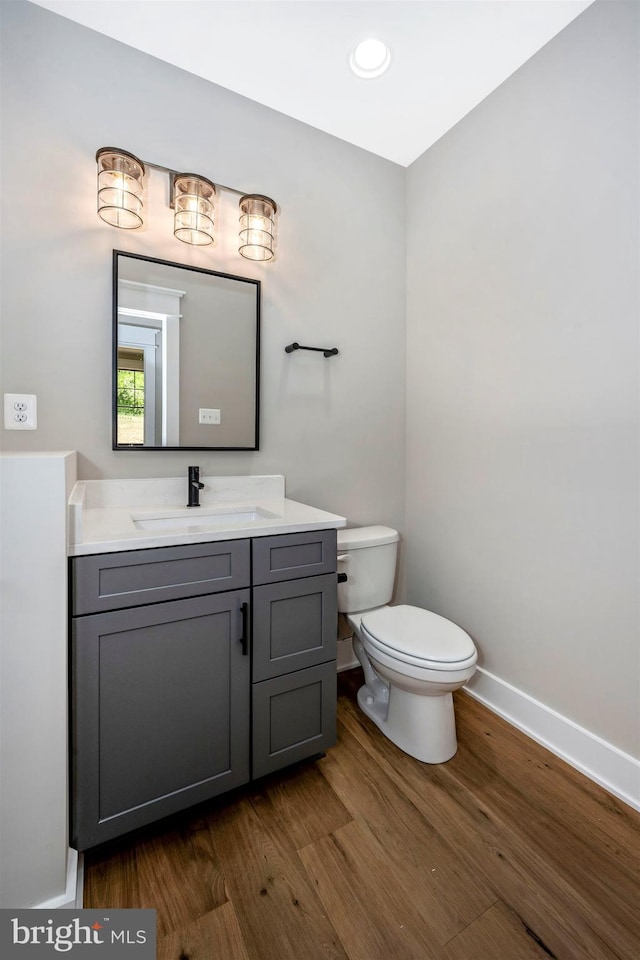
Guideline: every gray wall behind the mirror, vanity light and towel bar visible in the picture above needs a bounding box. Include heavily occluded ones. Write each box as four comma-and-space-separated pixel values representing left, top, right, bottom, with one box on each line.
1, 2, 405, 528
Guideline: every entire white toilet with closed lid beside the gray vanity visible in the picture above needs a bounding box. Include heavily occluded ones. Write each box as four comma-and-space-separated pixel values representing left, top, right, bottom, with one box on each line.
338, 527, 478, 763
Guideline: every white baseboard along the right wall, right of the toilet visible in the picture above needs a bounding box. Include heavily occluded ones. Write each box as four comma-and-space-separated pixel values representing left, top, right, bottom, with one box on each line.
464, 667, 640, 810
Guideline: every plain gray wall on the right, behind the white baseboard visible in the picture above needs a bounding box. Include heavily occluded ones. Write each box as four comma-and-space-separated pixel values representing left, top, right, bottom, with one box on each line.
406, 2, 640, 756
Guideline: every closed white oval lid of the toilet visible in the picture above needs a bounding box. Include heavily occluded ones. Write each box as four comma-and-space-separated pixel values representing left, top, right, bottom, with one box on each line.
362, 604, 476, 663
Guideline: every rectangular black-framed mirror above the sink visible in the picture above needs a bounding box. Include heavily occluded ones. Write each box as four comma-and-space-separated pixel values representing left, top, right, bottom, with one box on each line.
113, 250, 260, 450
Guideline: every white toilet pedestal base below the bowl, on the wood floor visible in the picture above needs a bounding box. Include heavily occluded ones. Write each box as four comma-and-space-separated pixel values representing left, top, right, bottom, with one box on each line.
358, 684, 458, 763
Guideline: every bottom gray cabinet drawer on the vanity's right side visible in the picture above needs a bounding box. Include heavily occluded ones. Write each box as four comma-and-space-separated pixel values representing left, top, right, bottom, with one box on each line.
252, 661, 337, 777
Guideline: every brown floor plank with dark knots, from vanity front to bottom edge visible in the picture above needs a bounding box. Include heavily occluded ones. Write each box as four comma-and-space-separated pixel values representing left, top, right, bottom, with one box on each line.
202, 797, 346, 960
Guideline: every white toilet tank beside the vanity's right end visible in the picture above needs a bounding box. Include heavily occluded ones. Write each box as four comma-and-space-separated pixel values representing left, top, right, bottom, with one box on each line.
338, 527, 400, 613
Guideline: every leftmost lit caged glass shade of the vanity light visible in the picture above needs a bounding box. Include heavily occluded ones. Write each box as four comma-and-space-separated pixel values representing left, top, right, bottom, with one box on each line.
96, 147, 145, 230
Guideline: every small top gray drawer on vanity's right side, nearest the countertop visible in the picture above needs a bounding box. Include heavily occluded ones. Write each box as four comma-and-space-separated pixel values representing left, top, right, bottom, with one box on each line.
253, 530, 337, 583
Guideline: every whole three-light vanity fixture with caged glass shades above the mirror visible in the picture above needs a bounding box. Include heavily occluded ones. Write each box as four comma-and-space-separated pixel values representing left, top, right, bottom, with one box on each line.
96, 147, 278, 261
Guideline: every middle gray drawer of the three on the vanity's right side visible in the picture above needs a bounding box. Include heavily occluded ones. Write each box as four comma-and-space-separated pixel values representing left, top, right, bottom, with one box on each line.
253, 573, 338, 683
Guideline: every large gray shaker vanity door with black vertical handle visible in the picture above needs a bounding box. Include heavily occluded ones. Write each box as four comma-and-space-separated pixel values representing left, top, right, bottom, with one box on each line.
72, 590, 250, 850
